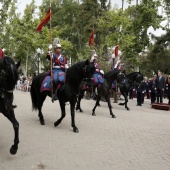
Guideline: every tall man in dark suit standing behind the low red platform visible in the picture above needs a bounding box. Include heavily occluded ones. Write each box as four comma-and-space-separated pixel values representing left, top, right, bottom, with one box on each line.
155, 71, 165, 103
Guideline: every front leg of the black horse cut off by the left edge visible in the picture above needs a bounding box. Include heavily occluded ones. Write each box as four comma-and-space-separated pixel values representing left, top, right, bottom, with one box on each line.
3, 108, 19, 155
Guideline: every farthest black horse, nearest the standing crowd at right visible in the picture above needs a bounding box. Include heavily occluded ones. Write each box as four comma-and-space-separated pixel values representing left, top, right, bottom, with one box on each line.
119, 72, 143, 110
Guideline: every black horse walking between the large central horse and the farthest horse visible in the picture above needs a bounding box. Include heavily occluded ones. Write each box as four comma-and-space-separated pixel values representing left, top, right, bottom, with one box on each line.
92, 70, 125, 118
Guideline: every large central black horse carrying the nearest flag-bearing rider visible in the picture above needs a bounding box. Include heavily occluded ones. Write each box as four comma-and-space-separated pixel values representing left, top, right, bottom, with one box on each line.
31, 60, 95, 132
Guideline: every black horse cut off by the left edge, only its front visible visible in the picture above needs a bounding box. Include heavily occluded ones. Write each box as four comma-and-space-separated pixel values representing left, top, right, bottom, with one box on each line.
0, 57, 20, 155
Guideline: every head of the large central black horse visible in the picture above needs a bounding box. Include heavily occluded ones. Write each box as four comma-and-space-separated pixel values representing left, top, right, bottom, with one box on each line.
83, 59, 95, 78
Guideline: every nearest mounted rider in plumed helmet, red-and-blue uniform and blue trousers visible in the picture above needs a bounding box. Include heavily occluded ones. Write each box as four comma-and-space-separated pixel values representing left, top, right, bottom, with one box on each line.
47, 39, 68, 101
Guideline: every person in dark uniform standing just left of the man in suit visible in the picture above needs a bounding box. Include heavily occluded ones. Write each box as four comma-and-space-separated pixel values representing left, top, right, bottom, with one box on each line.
149, 75, 156, 104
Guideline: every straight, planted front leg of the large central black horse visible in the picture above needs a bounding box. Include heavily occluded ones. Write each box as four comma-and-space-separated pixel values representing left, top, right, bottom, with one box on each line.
70, 99, 79, 133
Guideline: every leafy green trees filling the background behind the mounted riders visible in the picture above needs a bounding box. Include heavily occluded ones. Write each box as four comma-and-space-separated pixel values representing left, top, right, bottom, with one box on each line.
0, 0, 166, 74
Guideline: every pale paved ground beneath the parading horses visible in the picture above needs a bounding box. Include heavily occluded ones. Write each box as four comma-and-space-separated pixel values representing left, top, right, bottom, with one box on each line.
0, 91, 170, 170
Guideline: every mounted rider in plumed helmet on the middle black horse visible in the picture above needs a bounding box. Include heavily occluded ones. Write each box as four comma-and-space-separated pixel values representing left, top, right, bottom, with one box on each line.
90, 53, 104, 86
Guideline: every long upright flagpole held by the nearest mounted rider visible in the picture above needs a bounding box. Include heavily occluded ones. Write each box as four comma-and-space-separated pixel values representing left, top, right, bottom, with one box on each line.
50, 0, 54, 103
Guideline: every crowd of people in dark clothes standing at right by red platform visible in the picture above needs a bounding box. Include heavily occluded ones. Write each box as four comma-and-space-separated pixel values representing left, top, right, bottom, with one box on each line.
129, 71, 170, 106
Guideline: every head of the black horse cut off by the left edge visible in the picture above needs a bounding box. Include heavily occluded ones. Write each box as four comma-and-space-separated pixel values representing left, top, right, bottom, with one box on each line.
0, 57, 18, 91
